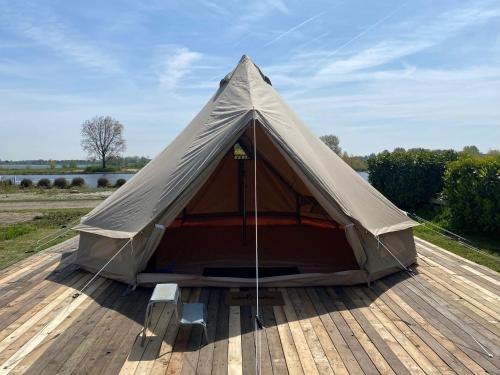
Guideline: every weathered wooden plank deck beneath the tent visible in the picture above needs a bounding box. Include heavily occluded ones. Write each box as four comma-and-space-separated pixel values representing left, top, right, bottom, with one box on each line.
0, 239, 500, 374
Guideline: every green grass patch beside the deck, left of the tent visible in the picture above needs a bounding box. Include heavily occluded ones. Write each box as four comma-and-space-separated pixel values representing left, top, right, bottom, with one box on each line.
0, 208, 90, 269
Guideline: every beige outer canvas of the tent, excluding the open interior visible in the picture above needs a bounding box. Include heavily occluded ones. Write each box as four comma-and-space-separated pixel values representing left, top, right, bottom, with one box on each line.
76, 56, 417, 284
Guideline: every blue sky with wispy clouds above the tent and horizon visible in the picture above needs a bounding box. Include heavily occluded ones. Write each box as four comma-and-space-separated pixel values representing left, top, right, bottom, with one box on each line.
0, 0, 500, 160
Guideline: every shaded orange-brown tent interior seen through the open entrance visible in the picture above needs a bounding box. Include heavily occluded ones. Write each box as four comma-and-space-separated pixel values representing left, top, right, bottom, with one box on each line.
147, 127, 359, 277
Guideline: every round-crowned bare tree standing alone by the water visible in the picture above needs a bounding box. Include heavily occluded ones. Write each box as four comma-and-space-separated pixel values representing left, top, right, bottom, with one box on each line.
82, 116, 126, 168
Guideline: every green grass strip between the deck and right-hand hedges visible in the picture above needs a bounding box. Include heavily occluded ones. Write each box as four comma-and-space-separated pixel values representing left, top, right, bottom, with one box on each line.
413, 207, 500, 272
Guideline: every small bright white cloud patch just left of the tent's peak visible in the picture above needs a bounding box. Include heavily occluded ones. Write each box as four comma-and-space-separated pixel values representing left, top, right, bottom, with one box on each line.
158, 47, 203, 91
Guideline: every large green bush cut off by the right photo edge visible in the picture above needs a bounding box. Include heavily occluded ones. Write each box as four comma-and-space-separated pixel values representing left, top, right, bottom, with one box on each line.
443, 155, 500, 232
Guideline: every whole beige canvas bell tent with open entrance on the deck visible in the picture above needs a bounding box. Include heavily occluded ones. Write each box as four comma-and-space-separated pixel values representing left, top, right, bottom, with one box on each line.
76, 56, 416, 286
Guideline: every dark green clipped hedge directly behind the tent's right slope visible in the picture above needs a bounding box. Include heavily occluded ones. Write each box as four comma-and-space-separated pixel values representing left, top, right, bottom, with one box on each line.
368, 149, 458, 208
